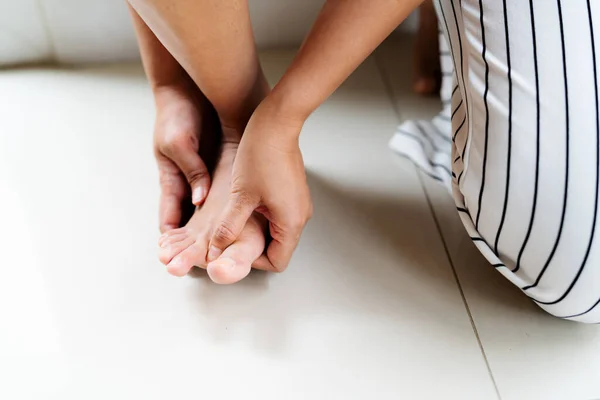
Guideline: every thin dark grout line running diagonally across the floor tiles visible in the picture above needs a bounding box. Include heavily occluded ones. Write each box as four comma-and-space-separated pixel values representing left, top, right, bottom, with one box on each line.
373, 47, 502, 400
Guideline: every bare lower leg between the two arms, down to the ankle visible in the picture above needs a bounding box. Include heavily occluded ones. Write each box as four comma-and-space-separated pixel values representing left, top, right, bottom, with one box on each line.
130, 0, 269, 129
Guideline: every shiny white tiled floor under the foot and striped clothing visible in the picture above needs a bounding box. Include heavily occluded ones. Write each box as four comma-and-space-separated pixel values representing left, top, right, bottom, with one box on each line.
0, 36, 600, 400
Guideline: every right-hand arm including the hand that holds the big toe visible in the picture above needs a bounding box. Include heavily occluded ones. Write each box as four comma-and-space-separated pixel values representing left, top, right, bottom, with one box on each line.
208, 0, 421, 271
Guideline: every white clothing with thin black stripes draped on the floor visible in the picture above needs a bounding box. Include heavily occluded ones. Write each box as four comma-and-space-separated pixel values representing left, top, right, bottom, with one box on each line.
390, 0, 600, 323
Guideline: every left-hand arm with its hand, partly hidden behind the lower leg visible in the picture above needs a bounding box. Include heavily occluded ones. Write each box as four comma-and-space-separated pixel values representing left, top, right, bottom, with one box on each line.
129, 7, 210, 232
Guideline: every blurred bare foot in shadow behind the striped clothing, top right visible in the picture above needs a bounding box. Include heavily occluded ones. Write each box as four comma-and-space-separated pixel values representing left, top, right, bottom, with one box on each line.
413, 0, 442, 96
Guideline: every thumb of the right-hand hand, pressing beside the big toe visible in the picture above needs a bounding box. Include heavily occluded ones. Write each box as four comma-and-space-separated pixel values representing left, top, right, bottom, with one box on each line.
207, 193, 258, 262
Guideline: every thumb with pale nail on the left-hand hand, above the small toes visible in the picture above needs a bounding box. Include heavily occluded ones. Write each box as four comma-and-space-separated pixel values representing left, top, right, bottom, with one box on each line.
171, 148, 210, 205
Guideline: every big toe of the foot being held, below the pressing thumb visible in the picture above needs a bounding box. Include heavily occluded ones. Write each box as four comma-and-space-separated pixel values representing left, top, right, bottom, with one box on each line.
207, 222, 265, 285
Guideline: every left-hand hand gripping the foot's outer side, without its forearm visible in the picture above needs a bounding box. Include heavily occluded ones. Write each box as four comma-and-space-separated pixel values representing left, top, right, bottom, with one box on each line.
154, 85, 210, 233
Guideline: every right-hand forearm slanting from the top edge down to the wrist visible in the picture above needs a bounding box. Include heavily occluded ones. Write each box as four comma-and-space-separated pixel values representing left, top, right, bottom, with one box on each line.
268, 0, 422, 119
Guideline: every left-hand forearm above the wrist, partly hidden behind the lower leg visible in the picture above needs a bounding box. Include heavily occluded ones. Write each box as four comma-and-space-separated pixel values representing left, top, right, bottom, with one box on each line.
127, 3, 190, 94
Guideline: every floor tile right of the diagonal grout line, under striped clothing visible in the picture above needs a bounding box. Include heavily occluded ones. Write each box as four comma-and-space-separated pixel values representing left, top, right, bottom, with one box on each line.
376, 37, 600, 400
